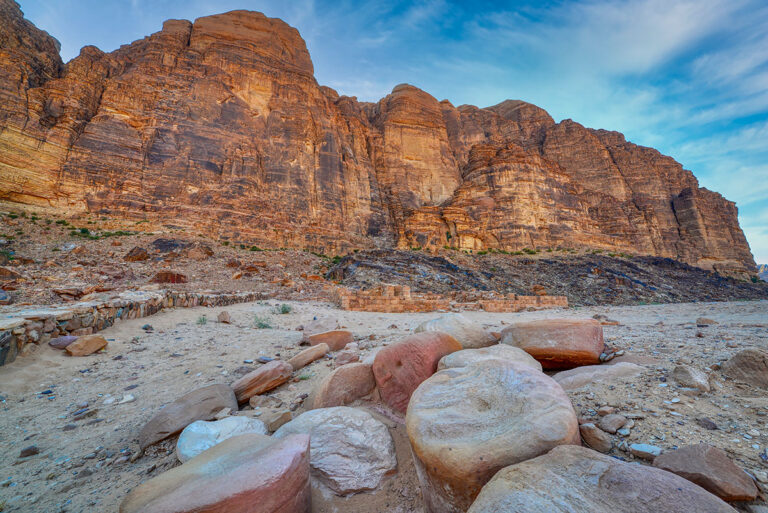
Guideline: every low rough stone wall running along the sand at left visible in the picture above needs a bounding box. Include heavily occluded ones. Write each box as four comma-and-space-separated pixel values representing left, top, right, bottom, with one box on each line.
0, 290, 268, 366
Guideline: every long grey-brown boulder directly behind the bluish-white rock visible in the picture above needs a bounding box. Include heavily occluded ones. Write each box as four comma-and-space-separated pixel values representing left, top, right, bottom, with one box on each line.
139, 385, 237, 450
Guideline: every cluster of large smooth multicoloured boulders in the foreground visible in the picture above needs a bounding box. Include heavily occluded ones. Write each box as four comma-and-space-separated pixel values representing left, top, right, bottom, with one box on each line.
120, 314, 764, 513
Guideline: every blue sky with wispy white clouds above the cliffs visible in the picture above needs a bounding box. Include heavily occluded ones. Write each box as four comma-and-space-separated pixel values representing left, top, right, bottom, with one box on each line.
18, 0, 768, 263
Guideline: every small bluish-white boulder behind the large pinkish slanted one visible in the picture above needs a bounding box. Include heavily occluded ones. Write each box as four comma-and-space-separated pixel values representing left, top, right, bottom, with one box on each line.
176, 417, 268, 463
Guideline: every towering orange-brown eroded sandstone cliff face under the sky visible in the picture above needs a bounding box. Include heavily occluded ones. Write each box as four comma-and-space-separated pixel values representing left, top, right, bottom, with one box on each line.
0, 0, 754, 272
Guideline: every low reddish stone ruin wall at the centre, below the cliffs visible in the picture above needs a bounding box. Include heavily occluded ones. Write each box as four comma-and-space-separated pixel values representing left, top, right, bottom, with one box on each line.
331, 285, 568, 313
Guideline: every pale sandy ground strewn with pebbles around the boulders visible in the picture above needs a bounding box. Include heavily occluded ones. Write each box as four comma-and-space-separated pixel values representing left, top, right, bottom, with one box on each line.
0, 301, 768, 513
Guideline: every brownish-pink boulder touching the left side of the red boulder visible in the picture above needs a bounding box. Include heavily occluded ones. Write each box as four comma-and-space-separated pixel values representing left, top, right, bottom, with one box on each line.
312, 363, 376, 408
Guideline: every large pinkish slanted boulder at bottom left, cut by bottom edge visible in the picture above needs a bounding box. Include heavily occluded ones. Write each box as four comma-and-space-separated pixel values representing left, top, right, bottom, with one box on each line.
120, 434, 311, 513
